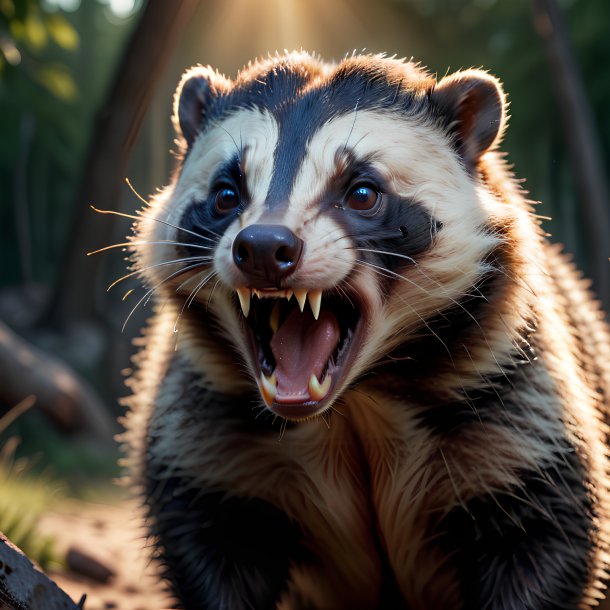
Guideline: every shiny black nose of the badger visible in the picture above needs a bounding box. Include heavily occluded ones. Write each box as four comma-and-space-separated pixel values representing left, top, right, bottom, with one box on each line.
233, 225, 303, 288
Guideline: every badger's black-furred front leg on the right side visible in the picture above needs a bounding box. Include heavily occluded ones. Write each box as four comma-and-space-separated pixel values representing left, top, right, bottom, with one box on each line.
444, 453, 596, 610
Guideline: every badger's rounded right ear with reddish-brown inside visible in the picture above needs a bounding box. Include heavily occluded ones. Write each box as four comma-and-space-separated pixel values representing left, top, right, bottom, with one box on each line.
431, 70, 506, 170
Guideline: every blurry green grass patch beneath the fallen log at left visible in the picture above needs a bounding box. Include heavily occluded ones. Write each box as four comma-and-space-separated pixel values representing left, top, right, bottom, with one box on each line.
0, 398, 125, 569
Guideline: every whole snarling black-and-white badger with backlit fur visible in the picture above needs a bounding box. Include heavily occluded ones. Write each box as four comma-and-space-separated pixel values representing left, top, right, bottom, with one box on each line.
119, 52, 610, 610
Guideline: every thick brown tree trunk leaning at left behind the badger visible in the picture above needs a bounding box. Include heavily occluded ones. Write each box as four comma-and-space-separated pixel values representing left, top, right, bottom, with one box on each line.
45, 0, 198, 325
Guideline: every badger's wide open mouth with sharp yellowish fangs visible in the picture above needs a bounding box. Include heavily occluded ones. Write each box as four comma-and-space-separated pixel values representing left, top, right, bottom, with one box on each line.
237, 288, 362, 419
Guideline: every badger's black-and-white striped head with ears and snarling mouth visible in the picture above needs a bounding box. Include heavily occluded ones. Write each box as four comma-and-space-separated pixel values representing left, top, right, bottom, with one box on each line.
138, 55, 504, 420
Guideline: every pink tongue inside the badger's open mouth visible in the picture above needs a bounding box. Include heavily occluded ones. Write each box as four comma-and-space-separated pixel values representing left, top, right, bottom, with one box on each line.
271, 308, 339, 402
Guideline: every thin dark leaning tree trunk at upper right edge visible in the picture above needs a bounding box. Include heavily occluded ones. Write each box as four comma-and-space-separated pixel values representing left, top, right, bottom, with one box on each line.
534, 0, 610, 312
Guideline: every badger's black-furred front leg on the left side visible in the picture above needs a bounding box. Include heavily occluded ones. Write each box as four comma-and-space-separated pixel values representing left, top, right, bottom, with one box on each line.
147, 477, 299, 610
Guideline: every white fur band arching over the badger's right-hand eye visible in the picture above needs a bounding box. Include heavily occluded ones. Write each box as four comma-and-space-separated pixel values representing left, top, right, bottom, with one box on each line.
287, 110, 485, 226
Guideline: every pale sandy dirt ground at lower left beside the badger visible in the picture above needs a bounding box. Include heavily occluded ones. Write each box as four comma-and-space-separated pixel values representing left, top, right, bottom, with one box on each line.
40, 502, 172, 610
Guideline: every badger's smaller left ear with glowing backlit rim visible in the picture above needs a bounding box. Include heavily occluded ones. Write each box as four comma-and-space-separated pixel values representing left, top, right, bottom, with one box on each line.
173, 66, 231, 149
